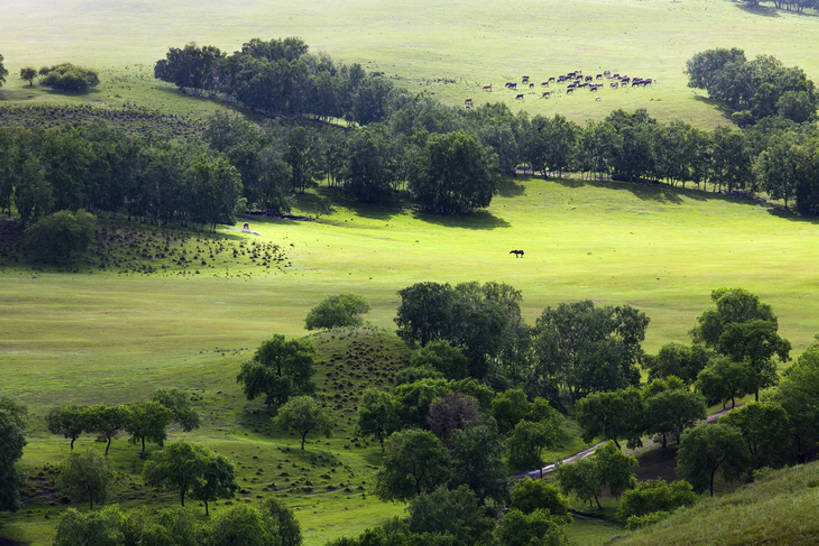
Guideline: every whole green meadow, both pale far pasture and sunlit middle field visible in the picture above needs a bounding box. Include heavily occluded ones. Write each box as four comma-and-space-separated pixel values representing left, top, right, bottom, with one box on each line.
0, 0, 819, 544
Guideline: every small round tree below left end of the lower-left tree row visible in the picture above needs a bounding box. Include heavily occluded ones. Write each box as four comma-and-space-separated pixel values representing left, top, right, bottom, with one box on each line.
57, 450, 113, 510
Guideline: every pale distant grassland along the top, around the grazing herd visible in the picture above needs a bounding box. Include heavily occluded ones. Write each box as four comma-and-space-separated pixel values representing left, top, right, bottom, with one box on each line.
0, 0, 819, 128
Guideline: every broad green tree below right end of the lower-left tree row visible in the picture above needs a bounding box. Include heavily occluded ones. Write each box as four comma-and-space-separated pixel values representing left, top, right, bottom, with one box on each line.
142, 442, 238, 514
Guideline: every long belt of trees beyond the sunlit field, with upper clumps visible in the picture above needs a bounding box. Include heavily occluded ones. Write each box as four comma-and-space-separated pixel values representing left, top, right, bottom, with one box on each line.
0, 39, 819, 227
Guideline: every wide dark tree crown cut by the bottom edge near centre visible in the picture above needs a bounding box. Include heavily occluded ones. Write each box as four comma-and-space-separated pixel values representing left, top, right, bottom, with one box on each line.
408, 485, 495, 545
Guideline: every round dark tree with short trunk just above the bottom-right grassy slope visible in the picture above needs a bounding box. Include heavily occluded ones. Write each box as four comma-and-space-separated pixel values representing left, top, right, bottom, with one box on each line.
677, 423, 750, 497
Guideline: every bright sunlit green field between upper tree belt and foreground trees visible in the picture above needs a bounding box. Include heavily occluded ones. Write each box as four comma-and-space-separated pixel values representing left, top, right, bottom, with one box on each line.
0, 179, 819, 544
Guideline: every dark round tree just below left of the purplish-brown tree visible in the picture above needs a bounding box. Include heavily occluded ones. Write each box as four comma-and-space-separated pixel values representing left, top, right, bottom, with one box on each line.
375, 429, 448, 500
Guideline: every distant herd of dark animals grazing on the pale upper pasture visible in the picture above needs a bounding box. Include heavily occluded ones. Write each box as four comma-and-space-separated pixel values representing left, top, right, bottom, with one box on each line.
464, 70, 657, 109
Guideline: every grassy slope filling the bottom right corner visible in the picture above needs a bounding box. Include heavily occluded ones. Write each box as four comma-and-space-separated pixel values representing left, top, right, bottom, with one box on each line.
617, 462, 819, 544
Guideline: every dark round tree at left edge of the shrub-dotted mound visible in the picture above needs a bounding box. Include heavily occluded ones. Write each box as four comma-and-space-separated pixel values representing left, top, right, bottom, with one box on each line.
236, 334, 315, 409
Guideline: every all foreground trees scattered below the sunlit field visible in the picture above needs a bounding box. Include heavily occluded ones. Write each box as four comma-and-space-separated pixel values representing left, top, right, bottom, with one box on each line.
0, 283, 819, 545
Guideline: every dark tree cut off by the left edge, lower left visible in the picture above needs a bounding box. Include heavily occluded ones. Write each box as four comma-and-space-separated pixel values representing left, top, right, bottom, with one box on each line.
0, 397, 26, 510
